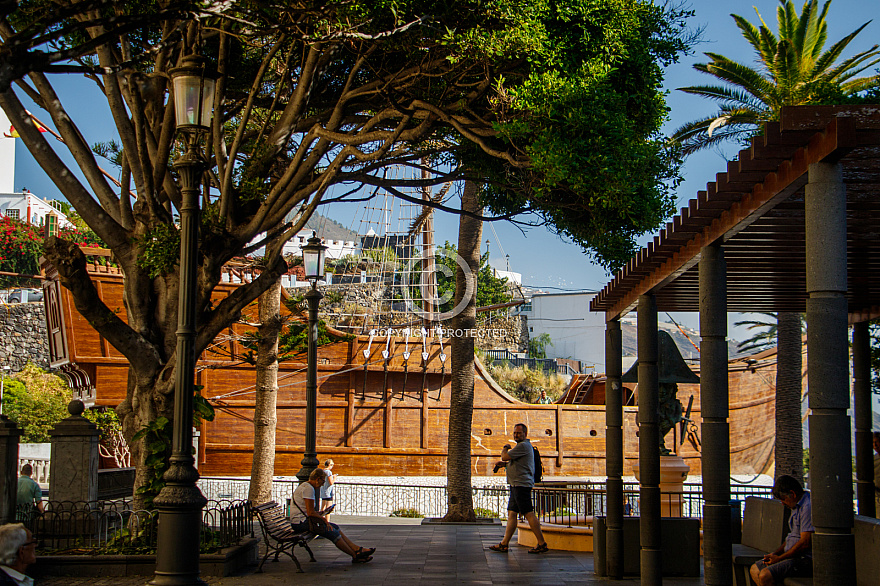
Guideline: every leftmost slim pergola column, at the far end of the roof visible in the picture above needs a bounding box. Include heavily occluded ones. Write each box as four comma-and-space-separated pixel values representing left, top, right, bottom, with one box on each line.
605, 318, 623, 580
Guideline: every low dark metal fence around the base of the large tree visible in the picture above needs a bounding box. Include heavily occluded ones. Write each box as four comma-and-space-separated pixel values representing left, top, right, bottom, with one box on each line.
16, 499, 254, 554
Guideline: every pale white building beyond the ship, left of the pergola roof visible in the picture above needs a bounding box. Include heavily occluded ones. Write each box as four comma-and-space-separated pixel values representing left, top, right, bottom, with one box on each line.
520, 291, 605, 372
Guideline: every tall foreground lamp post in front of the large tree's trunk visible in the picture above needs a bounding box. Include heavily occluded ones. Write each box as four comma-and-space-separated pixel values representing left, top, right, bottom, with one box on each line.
152, 55, 215, 586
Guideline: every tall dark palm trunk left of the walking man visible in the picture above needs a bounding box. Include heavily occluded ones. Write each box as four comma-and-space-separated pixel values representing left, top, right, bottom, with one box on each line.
443, 181, 483, 521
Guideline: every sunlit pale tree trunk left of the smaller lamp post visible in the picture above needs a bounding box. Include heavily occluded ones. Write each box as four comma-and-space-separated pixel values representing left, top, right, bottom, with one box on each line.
248, 279, 281, 505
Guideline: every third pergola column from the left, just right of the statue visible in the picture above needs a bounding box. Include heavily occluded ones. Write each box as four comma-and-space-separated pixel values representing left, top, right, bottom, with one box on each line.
700, 243, 733, 586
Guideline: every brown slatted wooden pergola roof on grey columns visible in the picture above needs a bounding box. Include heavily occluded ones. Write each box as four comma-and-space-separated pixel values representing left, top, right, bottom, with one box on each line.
591, 107, 880, 316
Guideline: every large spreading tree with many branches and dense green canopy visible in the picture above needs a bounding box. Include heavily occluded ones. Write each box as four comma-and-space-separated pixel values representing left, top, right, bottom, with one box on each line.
0, 0, 683, 504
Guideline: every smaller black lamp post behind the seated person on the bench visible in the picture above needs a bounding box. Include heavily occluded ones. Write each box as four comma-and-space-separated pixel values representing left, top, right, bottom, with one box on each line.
296, 232, 327, 482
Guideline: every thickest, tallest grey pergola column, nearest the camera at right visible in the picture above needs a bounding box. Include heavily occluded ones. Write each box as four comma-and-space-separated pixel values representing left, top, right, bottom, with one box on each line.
804, 163, 856, 586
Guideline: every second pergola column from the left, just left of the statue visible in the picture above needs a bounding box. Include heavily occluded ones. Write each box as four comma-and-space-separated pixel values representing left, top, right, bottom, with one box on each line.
638, 294, 663, 586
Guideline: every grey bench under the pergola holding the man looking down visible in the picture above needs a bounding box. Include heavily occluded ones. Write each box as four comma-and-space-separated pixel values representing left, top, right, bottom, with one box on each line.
733, 496, 791, 586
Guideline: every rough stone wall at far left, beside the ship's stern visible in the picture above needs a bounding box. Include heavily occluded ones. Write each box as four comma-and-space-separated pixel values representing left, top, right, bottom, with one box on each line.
0, 302, 49, 373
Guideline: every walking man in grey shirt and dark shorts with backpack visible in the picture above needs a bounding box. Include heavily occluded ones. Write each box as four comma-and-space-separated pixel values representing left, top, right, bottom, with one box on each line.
489, 423, 547, 553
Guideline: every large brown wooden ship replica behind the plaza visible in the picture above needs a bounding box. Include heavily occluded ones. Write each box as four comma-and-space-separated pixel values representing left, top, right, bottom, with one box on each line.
44, 264, 776, 477
